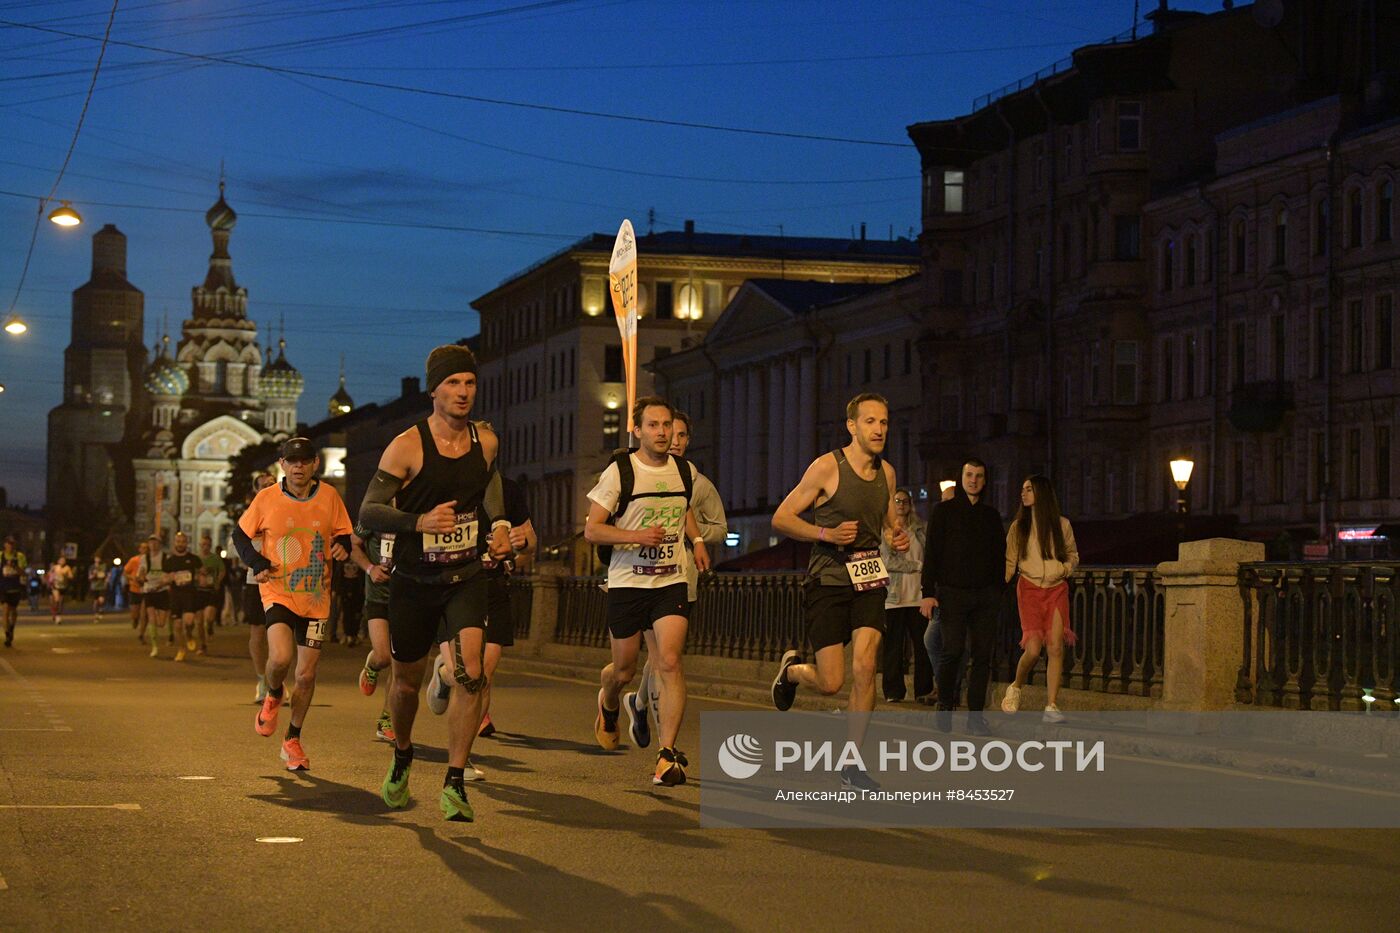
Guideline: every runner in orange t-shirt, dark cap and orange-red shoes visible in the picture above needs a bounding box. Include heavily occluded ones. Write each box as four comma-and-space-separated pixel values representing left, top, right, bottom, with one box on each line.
234, 437, 351, 770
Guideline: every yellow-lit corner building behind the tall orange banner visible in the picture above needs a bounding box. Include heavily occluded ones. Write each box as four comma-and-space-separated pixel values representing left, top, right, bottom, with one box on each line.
472, 223, 918, 549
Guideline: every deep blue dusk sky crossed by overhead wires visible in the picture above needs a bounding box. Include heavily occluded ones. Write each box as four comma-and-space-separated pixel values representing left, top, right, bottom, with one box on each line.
0, 0, 1219, 506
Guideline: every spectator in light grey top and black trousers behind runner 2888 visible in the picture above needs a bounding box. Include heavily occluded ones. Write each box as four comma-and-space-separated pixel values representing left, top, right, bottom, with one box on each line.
881, 489, 934, 703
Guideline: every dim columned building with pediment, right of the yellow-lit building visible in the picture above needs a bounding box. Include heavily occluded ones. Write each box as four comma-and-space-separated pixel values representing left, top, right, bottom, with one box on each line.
652, 276, 927, 560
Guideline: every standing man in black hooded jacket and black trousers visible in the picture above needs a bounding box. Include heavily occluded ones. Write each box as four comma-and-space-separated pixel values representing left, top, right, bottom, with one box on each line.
918, 457, 1007, 734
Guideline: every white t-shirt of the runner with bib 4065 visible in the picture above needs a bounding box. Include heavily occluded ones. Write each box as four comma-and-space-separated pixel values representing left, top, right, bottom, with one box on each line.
588, 454, 694, 590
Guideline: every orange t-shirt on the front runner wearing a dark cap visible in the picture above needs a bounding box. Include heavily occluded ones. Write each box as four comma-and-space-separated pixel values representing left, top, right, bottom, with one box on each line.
238, 482, 353, 619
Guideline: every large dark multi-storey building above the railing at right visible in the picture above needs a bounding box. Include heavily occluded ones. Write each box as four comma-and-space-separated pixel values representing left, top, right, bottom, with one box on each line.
909, 0, 1400, 546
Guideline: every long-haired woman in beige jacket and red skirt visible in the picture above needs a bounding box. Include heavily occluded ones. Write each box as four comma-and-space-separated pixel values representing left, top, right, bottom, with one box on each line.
1001, 475, 1079, 723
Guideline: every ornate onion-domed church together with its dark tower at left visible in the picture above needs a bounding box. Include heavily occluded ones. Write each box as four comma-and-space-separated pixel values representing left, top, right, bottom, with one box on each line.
48, 184, 304, 555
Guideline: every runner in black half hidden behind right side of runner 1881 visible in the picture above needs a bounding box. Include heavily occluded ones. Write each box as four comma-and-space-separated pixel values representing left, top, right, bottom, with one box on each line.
427, 467, 539, 750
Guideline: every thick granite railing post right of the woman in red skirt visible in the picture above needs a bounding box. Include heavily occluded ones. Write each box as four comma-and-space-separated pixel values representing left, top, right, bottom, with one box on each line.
1156, 538, 1264, 710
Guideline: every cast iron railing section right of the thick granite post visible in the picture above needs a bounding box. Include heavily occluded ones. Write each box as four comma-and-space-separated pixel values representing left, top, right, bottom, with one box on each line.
1236, 562, 1400, 710
